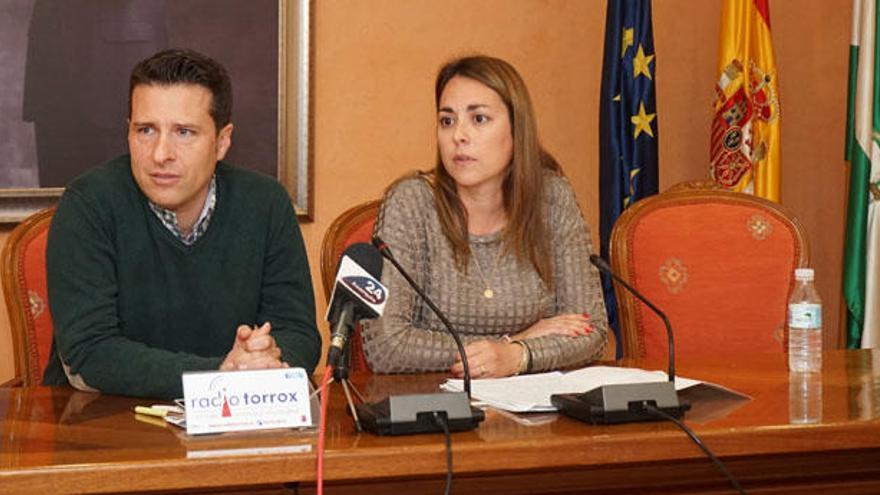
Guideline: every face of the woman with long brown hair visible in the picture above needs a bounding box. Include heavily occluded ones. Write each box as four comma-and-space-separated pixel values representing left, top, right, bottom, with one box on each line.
437, 76, 513, 193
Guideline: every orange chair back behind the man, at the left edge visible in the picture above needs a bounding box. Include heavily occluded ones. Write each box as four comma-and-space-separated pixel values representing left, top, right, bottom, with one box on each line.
0, 208, 55, 386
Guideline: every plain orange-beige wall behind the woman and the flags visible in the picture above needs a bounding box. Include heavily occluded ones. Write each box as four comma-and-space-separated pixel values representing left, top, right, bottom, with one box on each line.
0, 0, 850, 382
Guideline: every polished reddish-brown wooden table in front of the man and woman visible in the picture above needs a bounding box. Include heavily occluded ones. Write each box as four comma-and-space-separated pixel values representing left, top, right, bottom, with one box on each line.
0, 351, 880, 495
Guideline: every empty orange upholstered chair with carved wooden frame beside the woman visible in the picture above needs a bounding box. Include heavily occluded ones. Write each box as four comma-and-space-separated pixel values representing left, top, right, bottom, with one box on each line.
610, 188, 808, 358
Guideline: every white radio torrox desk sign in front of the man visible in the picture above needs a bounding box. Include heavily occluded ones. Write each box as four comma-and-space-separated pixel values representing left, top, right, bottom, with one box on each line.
183, 368, 312, 435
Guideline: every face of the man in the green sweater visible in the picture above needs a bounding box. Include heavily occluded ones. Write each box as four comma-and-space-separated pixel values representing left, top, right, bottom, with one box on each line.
128, 84, 232, 231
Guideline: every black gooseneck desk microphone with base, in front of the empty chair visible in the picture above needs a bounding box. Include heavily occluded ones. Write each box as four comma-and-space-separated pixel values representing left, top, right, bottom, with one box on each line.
550, 254, 690, 424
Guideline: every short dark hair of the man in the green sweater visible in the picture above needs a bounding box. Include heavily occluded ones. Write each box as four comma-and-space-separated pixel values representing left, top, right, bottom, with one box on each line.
128, 49, 232, 132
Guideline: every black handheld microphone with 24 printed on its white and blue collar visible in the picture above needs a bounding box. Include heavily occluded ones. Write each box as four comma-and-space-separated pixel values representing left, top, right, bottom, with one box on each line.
327, 242, 388, 369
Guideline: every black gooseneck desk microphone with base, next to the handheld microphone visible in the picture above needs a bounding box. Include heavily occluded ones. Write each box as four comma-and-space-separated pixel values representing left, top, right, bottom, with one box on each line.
356, 236, 486, 435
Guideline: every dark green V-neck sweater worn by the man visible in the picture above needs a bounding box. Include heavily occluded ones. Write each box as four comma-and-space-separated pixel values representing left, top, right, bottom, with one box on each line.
43, 155, 321, 397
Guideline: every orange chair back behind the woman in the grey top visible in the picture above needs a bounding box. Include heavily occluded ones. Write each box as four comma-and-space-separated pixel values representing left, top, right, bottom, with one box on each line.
321, 200, 381, 371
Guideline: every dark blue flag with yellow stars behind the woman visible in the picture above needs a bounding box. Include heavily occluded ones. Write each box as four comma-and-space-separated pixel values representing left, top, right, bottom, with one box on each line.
599, 0, 658, 357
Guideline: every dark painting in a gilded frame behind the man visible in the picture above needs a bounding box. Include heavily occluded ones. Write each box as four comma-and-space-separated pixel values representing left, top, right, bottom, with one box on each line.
0, 0, 313, 223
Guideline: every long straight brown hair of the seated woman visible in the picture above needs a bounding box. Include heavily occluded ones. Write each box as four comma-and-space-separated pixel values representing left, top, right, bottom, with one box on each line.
430, 56, 561, 290
